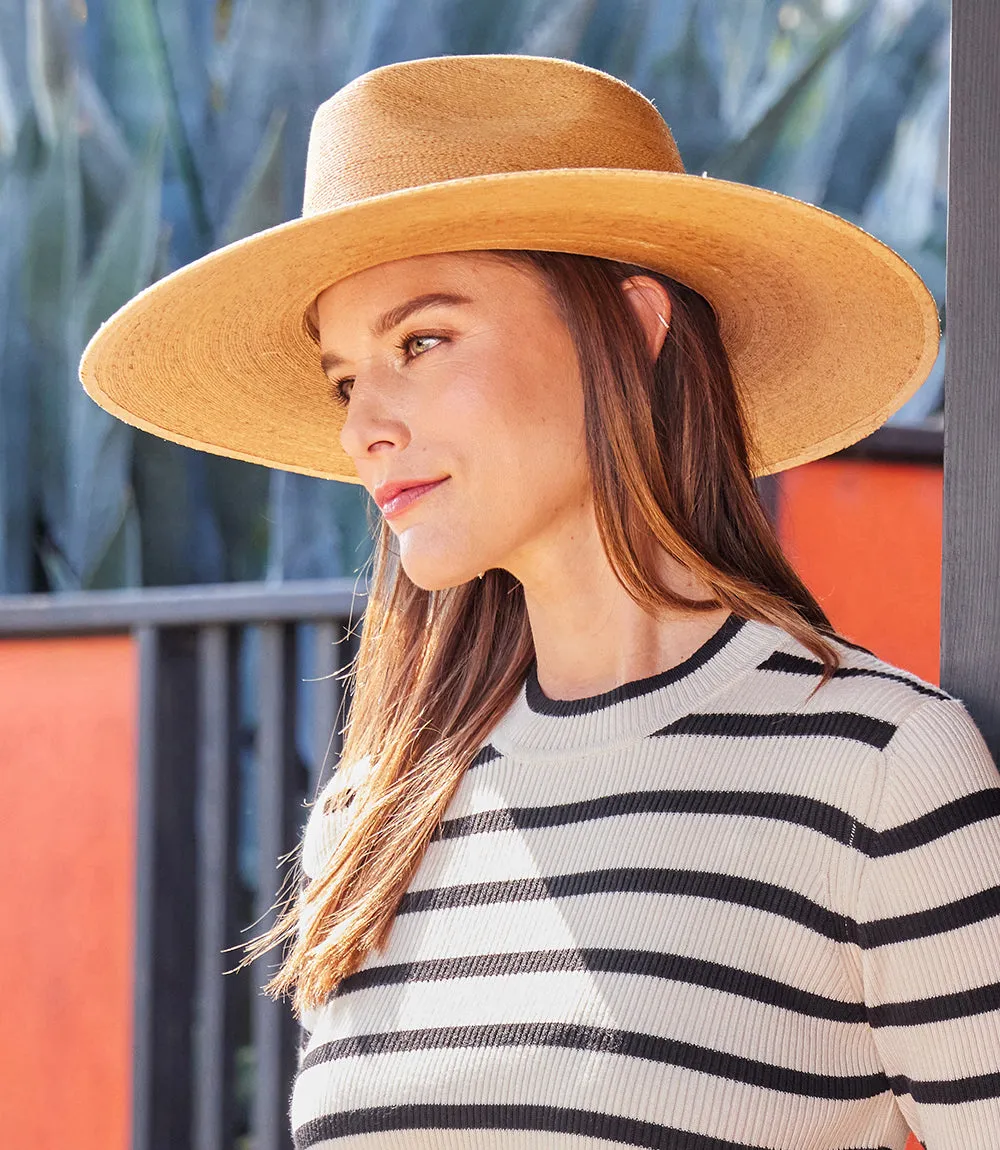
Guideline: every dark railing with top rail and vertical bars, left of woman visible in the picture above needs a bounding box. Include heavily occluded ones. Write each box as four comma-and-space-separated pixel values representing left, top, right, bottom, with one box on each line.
0, 580, 364, 1150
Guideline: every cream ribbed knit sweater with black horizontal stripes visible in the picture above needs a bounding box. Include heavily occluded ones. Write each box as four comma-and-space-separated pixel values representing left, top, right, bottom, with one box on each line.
292, 615, 1000, 1150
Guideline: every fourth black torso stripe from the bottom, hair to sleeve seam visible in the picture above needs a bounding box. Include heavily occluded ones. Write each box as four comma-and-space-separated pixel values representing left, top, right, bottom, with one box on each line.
398, 867, 857, 942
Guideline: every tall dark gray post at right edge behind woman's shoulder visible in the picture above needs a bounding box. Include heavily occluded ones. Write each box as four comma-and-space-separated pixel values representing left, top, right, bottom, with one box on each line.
941, 0, 1000, 759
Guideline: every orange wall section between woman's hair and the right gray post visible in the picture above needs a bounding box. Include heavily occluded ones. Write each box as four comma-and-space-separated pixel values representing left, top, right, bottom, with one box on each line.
778, 459, 943, 682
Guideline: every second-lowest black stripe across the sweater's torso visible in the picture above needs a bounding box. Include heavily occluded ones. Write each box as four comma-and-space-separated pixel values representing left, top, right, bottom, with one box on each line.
302, 1022, 889, 1102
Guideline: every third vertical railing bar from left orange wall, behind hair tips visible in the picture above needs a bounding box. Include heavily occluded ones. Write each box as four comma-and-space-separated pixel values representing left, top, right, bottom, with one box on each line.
254, 623, 295, 1150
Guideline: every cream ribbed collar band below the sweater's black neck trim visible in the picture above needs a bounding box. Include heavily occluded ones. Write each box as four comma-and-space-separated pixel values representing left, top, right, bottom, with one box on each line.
489, 613, 786, 758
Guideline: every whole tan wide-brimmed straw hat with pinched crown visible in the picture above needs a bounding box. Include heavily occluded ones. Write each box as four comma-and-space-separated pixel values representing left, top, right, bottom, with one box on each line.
79, 55, 939, 482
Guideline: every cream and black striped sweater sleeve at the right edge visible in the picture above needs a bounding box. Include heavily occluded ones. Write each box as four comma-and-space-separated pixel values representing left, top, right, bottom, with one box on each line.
857, 697, 1000, 1150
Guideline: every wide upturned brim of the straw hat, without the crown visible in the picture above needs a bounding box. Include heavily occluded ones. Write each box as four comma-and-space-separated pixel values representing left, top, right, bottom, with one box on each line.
79, 168, 940, 483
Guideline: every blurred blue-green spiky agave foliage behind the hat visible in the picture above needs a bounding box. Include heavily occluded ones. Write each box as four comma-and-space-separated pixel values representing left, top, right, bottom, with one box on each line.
0, 0, 948, 593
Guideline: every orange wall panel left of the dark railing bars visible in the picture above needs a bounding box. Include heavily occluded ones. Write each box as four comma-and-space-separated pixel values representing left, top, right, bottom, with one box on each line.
0, 636, 138, 1150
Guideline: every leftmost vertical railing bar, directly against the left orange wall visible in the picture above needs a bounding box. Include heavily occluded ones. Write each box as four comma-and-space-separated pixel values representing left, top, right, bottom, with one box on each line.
132, 627, 160, 1150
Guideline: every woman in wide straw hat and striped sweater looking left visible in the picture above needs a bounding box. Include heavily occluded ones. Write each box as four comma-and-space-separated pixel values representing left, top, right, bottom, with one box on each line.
82, 56, 1000, 1150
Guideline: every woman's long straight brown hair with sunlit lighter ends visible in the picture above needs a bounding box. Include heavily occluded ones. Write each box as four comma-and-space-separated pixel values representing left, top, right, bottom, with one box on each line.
247, 251, 839, 1012
